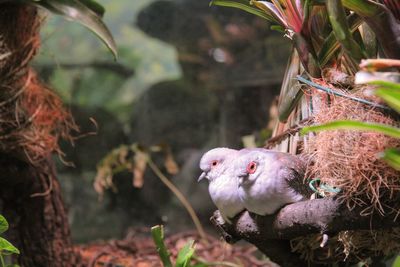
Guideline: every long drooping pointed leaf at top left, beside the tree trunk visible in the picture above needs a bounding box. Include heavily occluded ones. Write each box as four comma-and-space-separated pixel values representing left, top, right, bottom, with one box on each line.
31, 0, 117, 58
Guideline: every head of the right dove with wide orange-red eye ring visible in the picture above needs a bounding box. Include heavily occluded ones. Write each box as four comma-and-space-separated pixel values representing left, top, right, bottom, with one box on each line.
234, 149, 265, 186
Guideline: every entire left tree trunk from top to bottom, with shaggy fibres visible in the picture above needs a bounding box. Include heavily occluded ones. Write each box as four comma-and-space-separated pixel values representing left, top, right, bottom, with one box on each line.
0, 1, 80, 267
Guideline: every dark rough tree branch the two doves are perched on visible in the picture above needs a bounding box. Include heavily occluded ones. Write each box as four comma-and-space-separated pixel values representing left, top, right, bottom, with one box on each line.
211, 198, 400, 266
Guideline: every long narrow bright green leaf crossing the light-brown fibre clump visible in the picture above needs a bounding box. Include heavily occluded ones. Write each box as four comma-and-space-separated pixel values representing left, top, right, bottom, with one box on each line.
301, 120, 400, 138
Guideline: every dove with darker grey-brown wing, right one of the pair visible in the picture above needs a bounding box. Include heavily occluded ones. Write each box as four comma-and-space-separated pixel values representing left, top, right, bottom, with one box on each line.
233, 148, 312, 215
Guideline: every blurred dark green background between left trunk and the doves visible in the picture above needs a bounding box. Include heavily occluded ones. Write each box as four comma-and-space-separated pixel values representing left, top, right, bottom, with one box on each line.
34, 0, 290, 243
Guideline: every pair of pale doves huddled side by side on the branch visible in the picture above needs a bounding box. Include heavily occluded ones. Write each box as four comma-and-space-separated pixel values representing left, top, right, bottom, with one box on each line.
199, 147, 310, 223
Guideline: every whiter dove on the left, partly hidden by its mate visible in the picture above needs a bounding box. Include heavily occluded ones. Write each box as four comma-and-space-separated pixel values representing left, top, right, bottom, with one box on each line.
198, 147, 245, 224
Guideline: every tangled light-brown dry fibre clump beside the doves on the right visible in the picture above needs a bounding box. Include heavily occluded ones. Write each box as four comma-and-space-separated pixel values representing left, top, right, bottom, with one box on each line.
307, 88, 400, 214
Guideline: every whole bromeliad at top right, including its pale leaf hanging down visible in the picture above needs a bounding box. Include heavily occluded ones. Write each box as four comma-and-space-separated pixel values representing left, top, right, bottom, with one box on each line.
211, 0, 400, 122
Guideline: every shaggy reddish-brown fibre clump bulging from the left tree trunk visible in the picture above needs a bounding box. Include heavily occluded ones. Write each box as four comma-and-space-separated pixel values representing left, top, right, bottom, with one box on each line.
0, 71, 78, 164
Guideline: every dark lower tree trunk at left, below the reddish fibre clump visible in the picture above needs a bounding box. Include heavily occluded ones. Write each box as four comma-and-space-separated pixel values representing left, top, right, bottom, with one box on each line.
0, 155, 80, 267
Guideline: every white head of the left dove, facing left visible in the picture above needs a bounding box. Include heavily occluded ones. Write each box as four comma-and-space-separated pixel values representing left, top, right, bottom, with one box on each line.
198, 147, 238, 181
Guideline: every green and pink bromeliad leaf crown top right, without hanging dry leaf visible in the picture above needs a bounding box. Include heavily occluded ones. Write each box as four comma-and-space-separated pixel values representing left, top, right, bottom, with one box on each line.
210, 0, 400, 77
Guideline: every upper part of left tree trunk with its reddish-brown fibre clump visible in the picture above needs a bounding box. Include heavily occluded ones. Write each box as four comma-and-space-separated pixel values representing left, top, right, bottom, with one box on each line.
0, 6, 78, 164
